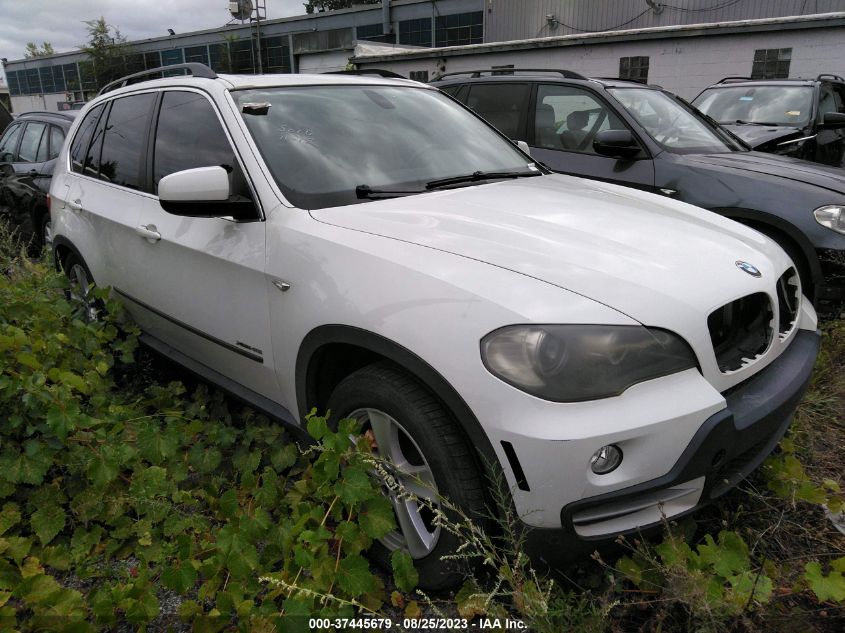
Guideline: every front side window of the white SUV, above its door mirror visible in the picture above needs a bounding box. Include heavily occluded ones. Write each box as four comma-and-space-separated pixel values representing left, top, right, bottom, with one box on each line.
153, 92, 249, 196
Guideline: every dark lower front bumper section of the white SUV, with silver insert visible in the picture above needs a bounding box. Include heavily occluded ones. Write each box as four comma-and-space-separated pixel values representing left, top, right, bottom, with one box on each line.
525, 330, 820, 566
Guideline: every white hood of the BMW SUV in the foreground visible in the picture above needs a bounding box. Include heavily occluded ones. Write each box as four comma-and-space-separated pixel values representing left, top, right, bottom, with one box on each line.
311, 174, 788, 331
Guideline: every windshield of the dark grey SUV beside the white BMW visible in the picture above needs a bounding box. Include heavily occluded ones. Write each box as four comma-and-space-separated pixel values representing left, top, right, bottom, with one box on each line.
609, 88, 743, 154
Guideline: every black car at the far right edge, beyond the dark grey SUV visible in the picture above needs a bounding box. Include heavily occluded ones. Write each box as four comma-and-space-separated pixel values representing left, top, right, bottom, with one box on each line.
693, 75, 845, 167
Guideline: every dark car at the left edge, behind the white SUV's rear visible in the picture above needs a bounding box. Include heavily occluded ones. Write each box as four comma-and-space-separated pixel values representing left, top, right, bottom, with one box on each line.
0, 112, 76, 252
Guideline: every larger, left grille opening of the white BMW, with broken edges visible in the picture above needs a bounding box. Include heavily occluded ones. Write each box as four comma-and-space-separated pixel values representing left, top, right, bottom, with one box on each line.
707, 292, 772, 372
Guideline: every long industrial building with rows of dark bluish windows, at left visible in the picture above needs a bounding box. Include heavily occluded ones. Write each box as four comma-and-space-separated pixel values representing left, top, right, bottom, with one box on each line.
4, 0, 484, 114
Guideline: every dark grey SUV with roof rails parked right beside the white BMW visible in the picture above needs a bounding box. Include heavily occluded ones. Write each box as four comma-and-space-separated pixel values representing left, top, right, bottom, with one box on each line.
433, 70, 845, 312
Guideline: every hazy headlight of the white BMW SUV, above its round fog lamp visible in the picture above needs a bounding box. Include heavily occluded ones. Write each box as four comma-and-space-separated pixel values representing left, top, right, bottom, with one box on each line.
481, 325, 697, 402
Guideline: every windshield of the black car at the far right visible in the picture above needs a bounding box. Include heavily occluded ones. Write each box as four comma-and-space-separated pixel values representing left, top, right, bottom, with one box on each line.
694, 86, 813, 127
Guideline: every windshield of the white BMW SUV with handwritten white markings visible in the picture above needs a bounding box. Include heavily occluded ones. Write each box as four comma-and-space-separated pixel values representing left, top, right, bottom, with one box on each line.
233, 85, 540, 209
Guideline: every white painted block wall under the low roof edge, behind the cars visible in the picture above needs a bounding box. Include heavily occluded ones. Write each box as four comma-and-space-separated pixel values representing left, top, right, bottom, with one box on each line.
356, 27, 845, 99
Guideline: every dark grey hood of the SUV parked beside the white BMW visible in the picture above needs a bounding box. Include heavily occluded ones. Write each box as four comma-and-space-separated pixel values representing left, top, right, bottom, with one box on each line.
677, 152, 845, 194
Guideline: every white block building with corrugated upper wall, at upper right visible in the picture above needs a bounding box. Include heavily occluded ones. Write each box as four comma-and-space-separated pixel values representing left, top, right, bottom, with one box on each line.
351, 0, 845, 99
